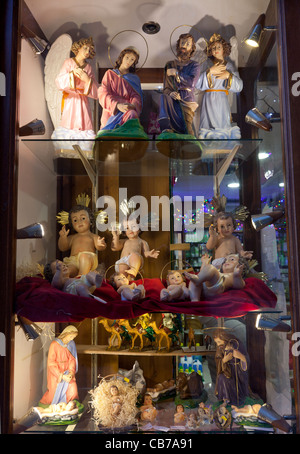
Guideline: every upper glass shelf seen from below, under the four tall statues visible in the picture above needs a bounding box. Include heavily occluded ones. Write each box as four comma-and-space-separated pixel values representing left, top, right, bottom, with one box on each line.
21, 138, 262, 177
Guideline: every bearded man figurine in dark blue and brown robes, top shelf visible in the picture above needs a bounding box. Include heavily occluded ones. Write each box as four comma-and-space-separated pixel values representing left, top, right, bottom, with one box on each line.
158, 33, 200, 135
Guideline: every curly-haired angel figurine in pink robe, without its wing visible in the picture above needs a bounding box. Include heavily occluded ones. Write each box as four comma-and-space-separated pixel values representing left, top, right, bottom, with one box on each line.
52, 38, 98, 139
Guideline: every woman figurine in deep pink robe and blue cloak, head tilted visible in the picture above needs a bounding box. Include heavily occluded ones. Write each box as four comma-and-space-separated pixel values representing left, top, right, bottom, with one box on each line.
98, 47, 143, 130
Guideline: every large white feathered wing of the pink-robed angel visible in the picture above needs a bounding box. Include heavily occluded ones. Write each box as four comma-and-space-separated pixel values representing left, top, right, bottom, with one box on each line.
44, 34, 72, 129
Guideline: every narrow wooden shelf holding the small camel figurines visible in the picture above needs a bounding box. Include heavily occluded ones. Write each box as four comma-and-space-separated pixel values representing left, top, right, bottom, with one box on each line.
76, 345, 216, 356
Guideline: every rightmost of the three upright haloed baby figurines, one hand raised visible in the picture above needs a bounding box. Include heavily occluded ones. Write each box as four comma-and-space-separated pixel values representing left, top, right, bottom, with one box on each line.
206, 212, 253, 269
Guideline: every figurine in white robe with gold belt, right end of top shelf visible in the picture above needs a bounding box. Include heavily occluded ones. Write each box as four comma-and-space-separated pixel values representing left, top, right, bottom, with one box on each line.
196, 33, 243, 139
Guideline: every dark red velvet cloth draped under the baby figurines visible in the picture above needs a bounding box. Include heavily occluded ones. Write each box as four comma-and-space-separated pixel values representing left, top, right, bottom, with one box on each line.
15, 277, 277, 322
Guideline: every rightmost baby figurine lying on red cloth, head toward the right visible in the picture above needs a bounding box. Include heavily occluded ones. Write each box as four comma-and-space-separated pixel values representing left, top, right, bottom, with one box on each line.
184, 254, 246, 301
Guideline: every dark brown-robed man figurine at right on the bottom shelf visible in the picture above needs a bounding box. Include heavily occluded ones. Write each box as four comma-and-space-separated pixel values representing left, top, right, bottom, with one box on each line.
213, 328, 249, 405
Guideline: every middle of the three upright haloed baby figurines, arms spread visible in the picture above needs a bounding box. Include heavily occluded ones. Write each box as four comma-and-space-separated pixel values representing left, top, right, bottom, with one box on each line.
111, 220, 159, 277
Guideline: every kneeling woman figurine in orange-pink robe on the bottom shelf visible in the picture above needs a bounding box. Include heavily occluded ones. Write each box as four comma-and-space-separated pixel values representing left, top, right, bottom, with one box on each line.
40, 325, 78, 405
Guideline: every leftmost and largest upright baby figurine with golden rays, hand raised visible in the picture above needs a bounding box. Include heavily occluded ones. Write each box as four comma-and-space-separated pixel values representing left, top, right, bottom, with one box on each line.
58, 205, 106, 277
